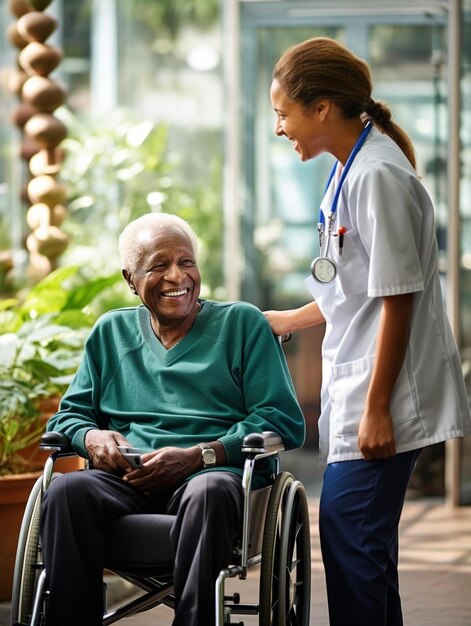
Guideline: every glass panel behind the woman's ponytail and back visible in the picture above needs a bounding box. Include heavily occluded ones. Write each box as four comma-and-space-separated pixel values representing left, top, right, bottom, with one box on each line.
368, 24, 448, 252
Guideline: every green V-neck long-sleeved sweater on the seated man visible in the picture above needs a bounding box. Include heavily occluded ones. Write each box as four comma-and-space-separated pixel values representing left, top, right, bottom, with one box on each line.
47, 300, 305, 478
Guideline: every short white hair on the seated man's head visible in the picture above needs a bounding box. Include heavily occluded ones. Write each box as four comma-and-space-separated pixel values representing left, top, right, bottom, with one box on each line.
118, 213, 198, 272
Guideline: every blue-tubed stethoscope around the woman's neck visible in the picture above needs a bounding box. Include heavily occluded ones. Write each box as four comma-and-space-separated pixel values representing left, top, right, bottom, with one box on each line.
311, 122, 373, 283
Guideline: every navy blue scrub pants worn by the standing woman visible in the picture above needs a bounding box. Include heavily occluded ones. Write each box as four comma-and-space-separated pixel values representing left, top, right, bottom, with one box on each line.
319, 450, 420, 626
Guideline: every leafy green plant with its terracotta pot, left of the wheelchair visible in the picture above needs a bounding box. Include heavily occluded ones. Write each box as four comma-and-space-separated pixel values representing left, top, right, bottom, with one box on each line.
0, 267, 121, 601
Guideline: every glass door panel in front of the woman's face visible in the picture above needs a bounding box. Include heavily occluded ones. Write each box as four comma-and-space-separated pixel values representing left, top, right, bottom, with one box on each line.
242, 27, 342, 308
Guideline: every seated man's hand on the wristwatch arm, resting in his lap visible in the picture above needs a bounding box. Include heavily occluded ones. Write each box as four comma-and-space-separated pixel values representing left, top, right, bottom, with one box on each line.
124, 446, 201, 493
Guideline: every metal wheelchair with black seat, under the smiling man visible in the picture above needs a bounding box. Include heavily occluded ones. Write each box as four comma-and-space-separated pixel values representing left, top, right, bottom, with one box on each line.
11, 432, 311, 626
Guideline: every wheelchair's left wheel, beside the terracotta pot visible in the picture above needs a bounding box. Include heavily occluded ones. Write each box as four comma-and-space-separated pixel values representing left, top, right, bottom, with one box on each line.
11, 474, 59, 626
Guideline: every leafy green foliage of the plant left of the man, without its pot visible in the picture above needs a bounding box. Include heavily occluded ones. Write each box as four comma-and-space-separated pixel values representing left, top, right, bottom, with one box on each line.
0, 267, 121, 475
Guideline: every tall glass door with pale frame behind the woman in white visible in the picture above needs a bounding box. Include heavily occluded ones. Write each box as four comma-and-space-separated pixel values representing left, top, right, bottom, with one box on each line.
229, 0, 468, 495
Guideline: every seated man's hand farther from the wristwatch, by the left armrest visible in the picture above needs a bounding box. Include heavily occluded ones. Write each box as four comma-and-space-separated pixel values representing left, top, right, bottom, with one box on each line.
85, 430, 132, 473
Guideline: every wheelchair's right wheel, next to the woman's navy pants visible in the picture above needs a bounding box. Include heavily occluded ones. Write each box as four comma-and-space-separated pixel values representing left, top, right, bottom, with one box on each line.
259, 472, 311, 626
